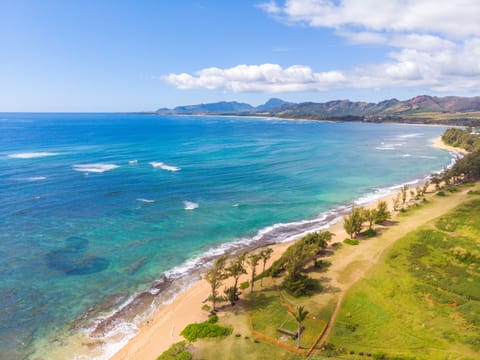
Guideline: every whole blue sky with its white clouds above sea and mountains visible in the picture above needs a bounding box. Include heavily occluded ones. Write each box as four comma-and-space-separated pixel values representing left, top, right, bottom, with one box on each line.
0, 0, 480, 111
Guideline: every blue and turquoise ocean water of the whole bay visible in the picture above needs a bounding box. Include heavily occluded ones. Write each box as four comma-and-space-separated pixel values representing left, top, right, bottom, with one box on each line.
0, 113, 451, 358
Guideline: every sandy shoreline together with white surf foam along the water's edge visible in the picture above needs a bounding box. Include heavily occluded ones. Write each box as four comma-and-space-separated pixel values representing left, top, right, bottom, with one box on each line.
61, 138, 463, 360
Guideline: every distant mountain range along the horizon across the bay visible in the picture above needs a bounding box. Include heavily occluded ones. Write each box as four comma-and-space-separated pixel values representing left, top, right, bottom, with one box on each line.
156, 95, 480, 125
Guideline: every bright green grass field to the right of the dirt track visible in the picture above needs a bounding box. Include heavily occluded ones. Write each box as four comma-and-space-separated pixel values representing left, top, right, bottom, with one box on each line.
329, 196, 480, 359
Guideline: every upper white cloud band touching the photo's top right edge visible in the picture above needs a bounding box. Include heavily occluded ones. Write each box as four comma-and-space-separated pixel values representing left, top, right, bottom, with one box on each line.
261, 0, 480, 38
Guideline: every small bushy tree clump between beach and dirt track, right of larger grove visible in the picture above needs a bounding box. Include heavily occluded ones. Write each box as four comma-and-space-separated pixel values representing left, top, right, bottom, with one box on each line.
343, 201, 392, 239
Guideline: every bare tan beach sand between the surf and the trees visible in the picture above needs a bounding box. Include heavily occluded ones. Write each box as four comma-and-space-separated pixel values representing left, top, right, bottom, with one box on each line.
112, 138, 458, 360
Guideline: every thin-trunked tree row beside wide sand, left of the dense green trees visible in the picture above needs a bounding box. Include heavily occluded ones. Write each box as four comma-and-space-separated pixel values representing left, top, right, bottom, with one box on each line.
204, 248, 273, 311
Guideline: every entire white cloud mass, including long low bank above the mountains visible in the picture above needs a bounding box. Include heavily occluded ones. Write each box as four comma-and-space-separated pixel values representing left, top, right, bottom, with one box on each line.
162, 0, 480, 93
